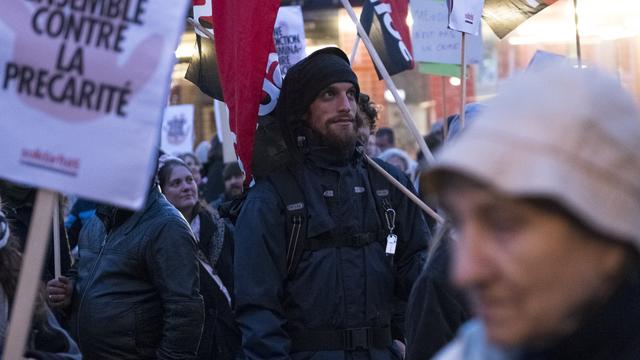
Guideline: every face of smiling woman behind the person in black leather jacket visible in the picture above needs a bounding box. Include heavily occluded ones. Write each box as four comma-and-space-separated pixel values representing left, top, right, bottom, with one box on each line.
162, 166, 198, 214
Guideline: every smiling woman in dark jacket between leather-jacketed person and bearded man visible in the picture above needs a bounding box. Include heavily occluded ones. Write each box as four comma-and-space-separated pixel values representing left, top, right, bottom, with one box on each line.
158, 156, 240, 360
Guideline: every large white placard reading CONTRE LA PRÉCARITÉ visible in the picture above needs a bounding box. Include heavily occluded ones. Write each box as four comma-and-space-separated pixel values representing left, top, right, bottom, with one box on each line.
0, 0, 188, 209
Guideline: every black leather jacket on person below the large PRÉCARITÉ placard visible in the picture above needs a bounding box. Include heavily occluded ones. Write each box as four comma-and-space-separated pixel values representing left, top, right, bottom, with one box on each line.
71, 187, 204, 360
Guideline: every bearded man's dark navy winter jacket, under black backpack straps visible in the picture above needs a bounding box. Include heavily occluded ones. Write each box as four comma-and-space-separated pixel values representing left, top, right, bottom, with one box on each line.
234, 148, 430, 360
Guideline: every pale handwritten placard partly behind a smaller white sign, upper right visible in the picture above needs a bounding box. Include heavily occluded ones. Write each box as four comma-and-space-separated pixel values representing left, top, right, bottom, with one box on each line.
409, 0, 483, 65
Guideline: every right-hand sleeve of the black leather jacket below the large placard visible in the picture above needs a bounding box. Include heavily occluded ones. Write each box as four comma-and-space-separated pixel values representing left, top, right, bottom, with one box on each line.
146, 219, 204, 359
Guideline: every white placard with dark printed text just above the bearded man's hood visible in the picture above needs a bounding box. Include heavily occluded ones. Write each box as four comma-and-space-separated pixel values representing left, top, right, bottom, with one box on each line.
273, 5, 306, 76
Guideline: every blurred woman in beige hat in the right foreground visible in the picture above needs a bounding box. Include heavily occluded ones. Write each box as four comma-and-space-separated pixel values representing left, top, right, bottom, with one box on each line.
429, 66, 640, 359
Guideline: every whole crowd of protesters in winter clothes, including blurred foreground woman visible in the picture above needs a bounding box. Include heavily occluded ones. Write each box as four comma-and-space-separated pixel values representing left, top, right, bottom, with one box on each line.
0, 48, 640, 360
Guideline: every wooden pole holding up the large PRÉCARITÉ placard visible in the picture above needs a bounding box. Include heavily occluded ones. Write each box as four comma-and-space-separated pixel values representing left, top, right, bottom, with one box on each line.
0, 189, 57, 359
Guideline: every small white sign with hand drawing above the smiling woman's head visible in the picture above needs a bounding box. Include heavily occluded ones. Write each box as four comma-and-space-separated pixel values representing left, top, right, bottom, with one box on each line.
160, 104, 193, 155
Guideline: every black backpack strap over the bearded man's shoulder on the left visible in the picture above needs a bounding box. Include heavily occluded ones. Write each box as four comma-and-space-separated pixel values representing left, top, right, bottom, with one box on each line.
269, 168, 308, 274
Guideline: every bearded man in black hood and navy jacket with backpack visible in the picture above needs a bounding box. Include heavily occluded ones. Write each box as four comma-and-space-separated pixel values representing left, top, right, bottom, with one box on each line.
234, 48, 430, 360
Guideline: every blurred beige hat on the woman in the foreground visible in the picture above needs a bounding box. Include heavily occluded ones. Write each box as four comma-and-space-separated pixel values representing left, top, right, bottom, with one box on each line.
427, 65, 640, 249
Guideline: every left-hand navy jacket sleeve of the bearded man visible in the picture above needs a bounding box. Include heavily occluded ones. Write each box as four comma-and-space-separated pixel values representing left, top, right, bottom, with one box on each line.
234, 182, 291, 360
